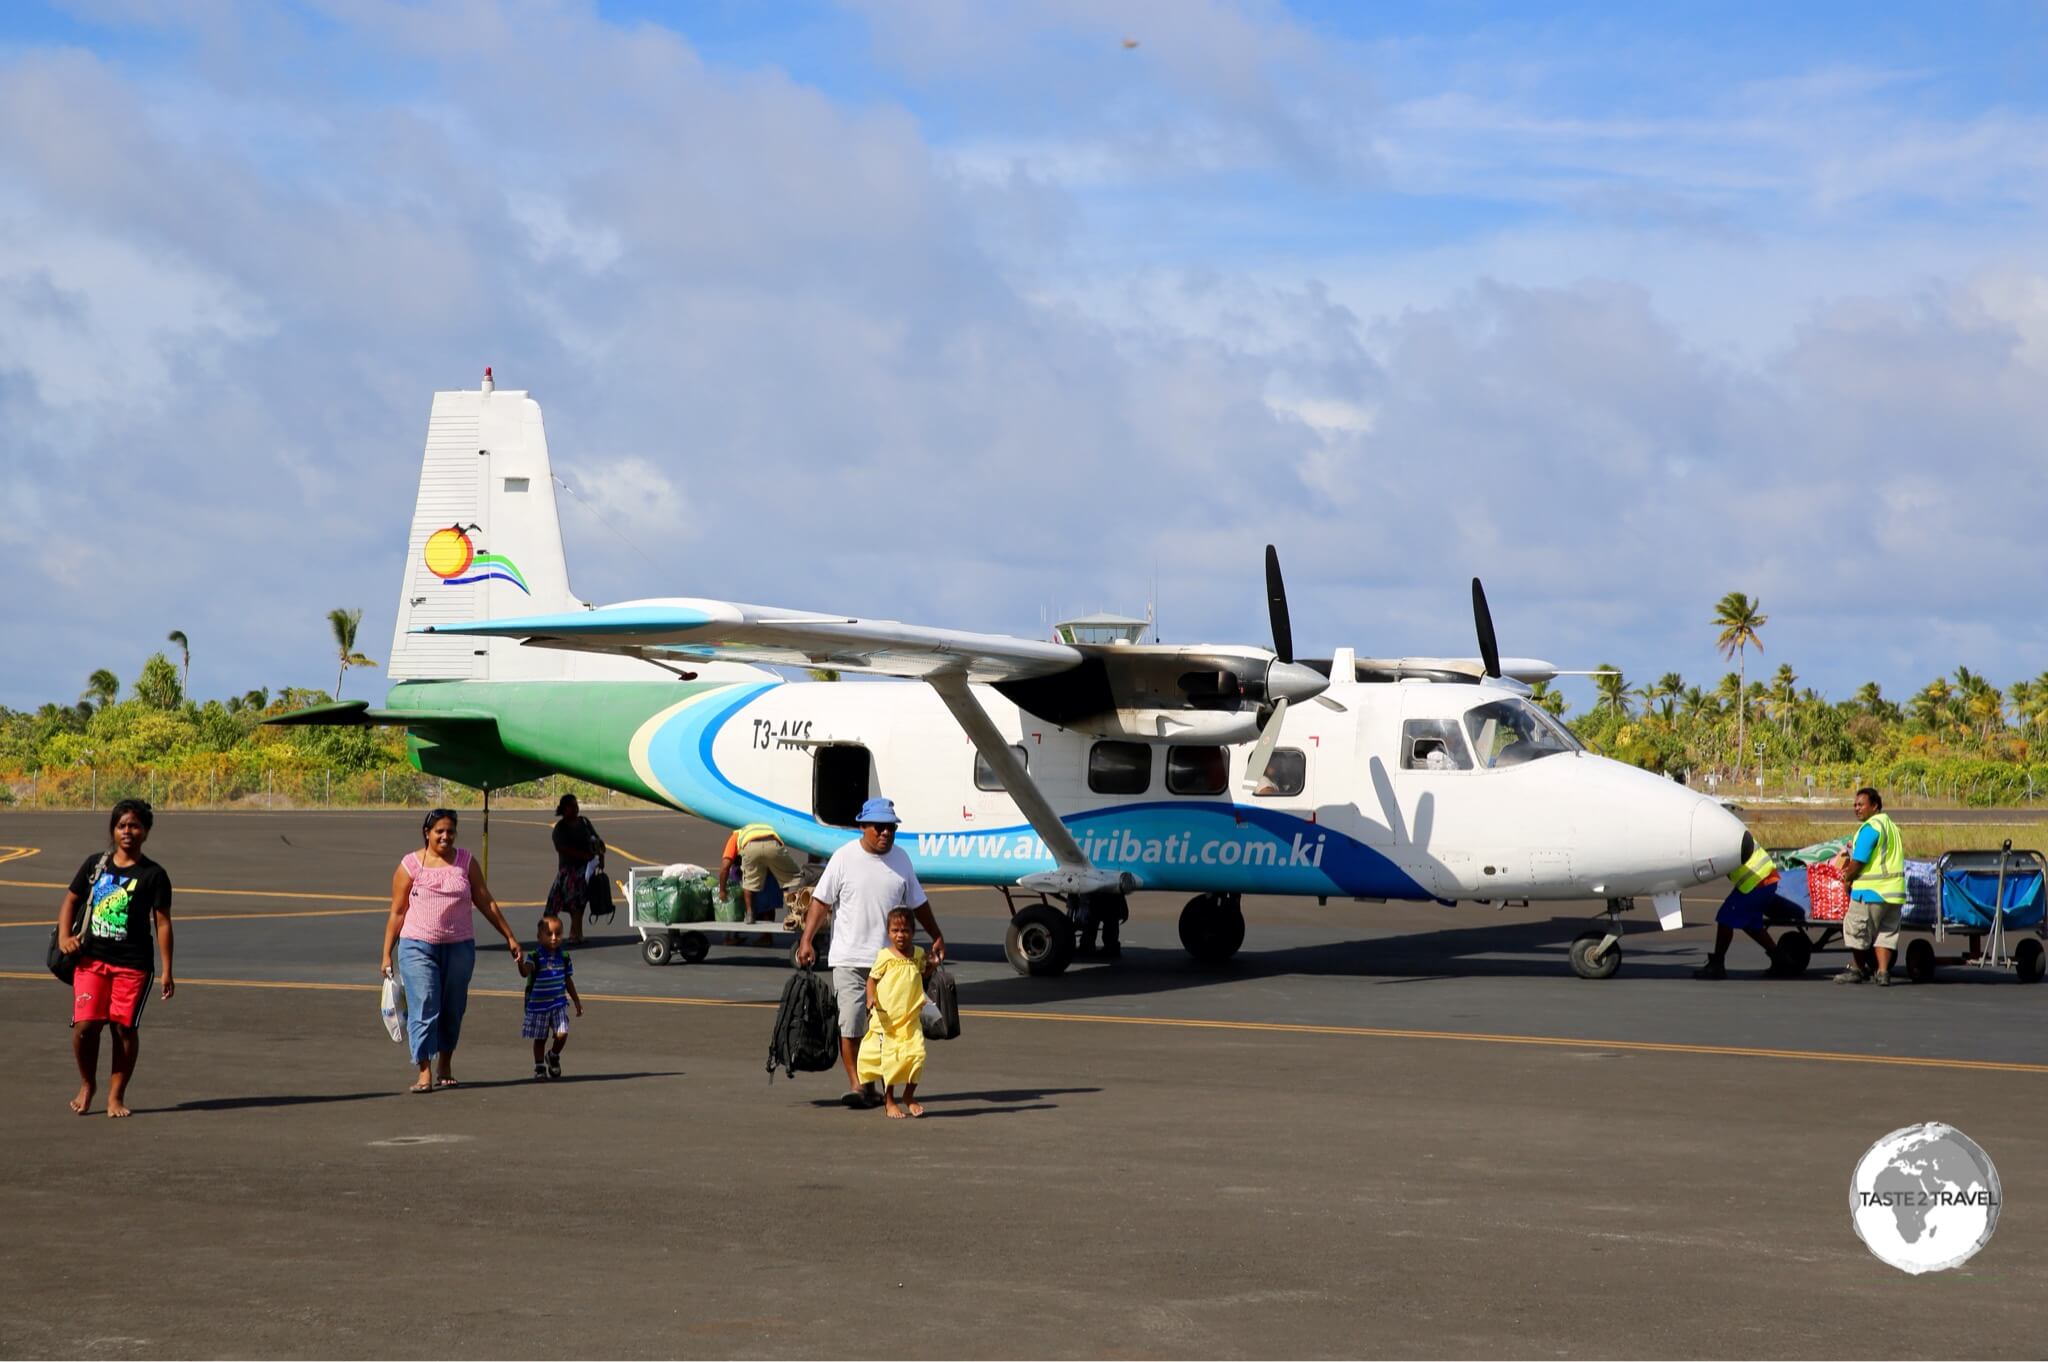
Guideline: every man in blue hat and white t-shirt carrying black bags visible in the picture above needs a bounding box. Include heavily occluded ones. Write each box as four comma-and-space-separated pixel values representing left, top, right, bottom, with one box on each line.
797, 797, 946, 1106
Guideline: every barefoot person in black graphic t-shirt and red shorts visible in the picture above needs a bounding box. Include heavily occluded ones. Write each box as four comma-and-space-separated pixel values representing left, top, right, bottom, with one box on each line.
57, 799, 178, 1116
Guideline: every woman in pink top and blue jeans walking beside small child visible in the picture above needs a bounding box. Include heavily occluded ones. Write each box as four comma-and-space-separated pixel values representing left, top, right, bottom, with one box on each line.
383, 809, 520, 1092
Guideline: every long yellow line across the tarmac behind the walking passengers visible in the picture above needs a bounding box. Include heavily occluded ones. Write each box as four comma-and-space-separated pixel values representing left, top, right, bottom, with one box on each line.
0, 971, 2048, 1073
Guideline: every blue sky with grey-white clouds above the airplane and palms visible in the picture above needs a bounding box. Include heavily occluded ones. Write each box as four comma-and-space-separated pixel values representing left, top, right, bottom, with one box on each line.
0, 0, 2048, 709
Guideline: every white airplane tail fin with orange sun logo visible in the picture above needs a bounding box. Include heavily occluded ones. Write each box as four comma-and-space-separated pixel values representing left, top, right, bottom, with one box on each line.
389, 369, 582, 682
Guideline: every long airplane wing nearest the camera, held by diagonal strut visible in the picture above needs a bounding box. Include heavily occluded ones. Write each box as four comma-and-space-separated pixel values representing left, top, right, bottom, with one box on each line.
416, 598, 1083, 684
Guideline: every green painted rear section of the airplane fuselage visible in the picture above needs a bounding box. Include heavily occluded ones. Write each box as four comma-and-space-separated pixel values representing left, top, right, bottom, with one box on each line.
385, 680, 729, 807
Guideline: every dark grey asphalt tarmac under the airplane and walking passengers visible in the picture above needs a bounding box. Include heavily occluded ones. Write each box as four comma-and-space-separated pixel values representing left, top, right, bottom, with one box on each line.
0, 809, 2048, 1358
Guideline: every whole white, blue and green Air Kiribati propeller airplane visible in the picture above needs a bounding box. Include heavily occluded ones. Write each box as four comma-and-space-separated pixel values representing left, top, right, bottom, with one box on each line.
285, 371, 1753, 977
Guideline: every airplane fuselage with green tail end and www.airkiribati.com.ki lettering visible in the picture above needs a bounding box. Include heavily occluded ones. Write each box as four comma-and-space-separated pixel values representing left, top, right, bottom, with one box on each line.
389, 680, 1743, 901
